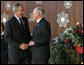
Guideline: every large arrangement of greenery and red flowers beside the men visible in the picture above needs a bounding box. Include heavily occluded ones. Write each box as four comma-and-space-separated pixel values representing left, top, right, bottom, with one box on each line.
50, 23, 83, 64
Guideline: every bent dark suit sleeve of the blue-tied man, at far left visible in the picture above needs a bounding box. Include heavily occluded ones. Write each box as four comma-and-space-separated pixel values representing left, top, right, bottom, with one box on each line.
5, 22, 20, 47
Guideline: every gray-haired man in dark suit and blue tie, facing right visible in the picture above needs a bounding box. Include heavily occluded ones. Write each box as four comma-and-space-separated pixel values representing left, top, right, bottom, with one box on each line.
5, 3, 31, 64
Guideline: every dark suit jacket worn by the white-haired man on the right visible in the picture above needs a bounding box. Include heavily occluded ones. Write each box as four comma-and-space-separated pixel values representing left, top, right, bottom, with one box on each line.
31, 18, 51, 59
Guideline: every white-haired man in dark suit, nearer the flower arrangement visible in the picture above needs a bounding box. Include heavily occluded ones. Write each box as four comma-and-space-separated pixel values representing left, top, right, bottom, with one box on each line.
29, 7, 51, 64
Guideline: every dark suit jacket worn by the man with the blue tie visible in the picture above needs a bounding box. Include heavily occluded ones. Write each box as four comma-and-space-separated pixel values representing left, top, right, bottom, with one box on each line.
5, 16, 31, 58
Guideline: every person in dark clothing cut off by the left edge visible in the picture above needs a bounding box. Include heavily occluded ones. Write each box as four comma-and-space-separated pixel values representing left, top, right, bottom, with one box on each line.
1, 23, 8, 64
